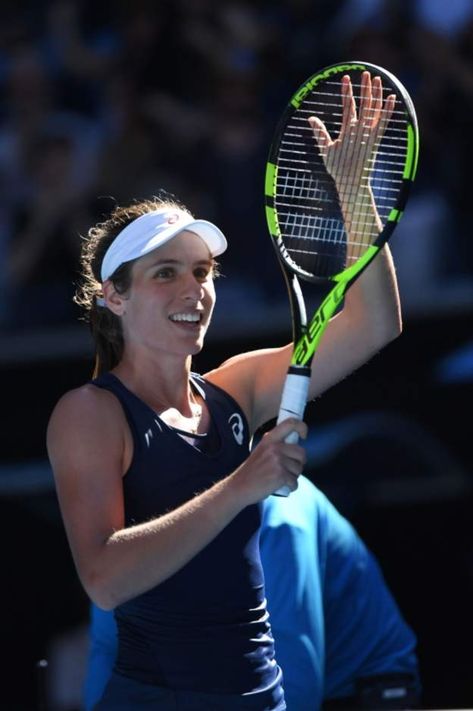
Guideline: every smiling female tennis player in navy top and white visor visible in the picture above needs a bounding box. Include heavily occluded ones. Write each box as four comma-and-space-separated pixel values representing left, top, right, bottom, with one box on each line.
48, 73, 401, 711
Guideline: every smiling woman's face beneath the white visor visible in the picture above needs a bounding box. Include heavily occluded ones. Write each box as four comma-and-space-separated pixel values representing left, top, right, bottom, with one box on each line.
115, 231, 215, 356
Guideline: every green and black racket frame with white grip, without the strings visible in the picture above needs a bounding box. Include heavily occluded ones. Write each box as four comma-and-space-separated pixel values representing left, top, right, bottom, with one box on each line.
265, 61, 419, 496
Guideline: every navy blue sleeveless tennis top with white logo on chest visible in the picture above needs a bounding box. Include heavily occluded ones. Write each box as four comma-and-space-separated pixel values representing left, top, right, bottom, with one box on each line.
92, 373, 278, 694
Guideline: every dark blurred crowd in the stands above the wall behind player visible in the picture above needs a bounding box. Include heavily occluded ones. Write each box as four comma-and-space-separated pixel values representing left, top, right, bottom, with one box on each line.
0, 0, 473, 333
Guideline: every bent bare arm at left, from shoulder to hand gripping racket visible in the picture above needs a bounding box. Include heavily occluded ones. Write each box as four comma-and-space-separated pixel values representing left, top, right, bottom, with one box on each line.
48, 385, 305, 609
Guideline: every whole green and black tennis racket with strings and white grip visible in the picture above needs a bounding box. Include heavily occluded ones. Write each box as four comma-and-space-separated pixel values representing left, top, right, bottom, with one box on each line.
265, 62, 419, 496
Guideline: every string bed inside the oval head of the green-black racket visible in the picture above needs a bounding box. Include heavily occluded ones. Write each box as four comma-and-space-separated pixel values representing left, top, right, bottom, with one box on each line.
275, 80, 408, 277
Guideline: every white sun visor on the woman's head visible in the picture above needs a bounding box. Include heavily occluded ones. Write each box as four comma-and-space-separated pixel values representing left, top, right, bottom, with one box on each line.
101, 207, 227, 281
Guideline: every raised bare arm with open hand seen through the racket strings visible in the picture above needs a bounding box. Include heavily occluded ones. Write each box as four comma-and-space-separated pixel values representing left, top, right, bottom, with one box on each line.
207, 72, 401, 429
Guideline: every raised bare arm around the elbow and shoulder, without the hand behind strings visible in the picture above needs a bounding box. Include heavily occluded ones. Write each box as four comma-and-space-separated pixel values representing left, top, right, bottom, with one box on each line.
206, 247, 401, 432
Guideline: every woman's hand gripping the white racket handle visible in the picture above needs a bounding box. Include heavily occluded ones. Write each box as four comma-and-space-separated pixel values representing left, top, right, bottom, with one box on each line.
233, 417, 307, 505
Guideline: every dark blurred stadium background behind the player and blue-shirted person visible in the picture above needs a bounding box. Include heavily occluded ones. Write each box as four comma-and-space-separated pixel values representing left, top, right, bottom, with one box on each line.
0, 0, 473, 711
